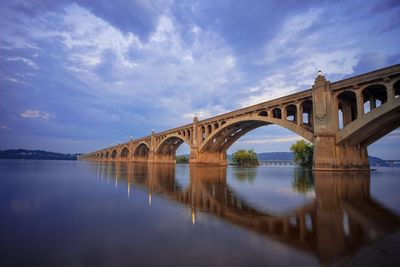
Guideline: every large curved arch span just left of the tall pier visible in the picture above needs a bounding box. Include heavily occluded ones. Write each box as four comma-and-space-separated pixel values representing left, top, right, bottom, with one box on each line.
199, 116, 314, 152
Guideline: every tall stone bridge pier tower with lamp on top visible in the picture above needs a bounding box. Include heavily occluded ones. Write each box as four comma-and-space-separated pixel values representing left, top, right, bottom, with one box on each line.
312, 72, 369, 170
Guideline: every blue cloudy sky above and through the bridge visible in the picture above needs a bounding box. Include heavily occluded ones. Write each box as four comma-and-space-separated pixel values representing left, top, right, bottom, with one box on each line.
0, 0, 400, 159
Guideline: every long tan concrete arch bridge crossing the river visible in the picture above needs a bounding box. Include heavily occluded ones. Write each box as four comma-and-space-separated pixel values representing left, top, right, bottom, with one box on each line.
81, 64, 400, 170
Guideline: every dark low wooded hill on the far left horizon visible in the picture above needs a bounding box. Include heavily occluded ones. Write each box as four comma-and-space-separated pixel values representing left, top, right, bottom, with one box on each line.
0, 149, 78, 160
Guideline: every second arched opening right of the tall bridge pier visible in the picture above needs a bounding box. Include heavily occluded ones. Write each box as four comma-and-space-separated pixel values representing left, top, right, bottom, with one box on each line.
362, 84, 387, 113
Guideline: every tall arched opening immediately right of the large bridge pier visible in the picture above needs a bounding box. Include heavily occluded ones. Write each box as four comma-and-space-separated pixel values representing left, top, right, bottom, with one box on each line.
337, 91, 357, 129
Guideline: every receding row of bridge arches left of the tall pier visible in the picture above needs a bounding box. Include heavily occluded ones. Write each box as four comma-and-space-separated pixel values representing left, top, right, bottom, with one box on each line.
86, 98, 313, 161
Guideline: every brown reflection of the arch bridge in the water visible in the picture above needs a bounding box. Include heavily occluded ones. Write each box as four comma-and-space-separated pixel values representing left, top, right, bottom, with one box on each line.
93, 162, 400, 262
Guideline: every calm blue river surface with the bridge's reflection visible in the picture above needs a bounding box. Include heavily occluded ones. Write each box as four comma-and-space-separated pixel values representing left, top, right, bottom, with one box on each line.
0, 160, 400, 267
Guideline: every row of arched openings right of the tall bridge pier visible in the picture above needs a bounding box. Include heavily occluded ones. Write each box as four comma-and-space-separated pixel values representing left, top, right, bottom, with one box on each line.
336, 80, 400, 129
